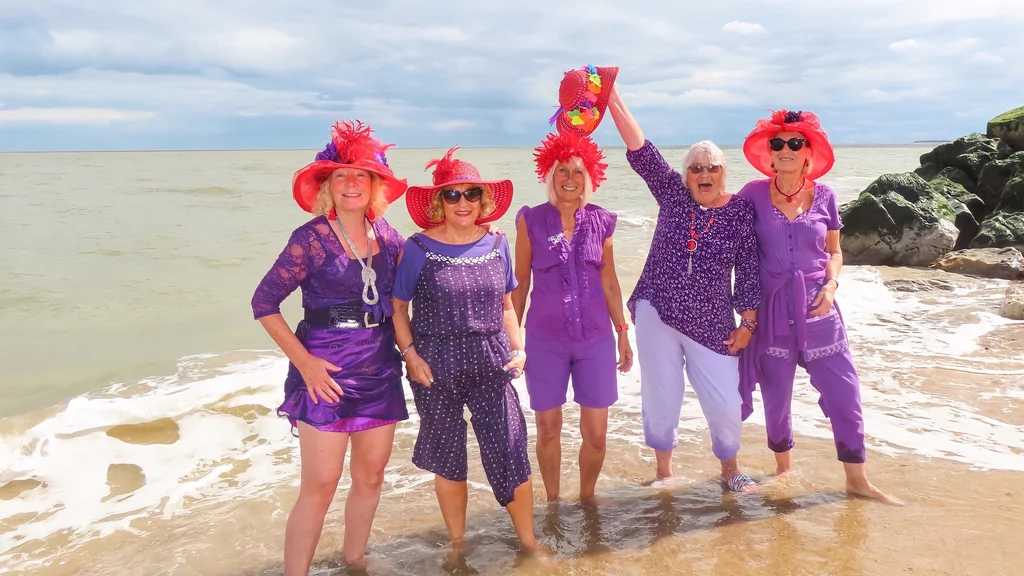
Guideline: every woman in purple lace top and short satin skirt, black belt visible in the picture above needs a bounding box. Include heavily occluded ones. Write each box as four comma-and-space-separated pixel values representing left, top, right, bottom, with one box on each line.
252, 122, 409, 576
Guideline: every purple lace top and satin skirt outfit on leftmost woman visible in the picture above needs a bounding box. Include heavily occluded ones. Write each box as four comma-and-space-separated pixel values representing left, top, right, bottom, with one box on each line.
252, 216, 409, 433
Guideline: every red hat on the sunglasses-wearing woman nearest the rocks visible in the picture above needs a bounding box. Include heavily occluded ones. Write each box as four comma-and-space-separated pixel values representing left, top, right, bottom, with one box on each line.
743, 110, 836, 180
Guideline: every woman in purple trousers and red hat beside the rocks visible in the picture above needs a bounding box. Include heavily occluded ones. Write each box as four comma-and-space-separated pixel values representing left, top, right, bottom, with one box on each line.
738, 110, 902, 504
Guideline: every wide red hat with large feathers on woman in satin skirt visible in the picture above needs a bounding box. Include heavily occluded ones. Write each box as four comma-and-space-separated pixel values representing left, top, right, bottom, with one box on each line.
292, 120, 409, 220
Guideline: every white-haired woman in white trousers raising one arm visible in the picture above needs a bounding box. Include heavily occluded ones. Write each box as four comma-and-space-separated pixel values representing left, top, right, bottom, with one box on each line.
609, 84, 761, 492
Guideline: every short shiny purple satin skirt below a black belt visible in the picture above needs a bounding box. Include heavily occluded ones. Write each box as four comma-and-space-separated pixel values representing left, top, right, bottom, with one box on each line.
278, 322, 409, 431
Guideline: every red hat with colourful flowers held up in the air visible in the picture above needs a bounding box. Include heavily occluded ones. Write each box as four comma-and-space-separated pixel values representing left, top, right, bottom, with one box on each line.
548, 65, 618, 136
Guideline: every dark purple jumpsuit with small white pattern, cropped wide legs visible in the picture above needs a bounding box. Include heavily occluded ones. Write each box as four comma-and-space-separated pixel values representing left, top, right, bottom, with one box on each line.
411, 236, 530, 506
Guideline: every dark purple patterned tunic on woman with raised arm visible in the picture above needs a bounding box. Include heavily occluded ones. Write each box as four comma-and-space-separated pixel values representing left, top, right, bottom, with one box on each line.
626, 140, 761, 356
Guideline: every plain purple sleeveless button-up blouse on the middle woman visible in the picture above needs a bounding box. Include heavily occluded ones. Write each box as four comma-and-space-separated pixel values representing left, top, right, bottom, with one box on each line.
516, 202, 616, 340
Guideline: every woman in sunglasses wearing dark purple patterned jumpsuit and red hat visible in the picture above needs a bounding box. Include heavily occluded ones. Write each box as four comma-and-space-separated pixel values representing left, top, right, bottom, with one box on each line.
394, 149, 540, 558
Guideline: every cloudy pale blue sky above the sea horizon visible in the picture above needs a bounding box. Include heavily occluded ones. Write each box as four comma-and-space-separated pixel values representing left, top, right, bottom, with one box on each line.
0, 0, 1024, 151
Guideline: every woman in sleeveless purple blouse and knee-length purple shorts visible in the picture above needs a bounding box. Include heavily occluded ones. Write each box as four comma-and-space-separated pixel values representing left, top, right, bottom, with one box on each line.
512, 129, 633, 502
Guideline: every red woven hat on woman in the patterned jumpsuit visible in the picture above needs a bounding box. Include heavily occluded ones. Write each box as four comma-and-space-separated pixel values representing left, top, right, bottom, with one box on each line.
406, 147, 512, 230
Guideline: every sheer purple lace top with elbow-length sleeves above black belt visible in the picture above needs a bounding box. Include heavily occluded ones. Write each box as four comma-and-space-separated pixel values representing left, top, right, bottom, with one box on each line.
252, 216, 404, 319
